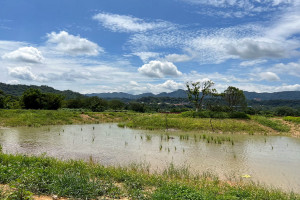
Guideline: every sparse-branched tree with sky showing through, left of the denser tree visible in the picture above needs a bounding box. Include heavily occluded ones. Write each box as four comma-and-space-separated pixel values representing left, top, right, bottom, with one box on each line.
186, 80, 216, 112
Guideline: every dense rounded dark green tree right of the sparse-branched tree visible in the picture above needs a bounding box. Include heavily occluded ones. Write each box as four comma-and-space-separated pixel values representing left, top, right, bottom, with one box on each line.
222, 86, 247, 111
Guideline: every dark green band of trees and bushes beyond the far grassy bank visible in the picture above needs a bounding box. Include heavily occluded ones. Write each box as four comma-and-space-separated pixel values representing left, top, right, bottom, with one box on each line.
0, 84, 300, 116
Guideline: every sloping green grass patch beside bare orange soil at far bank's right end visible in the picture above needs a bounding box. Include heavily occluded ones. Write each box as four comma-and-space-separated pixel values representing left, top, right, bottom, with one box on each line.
252, 116, 290, 132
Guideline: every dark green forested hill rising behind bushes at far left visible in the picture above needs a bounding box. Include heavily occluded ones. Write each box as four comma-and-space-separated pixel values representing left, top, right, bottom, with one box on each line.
0, 83, 84, 99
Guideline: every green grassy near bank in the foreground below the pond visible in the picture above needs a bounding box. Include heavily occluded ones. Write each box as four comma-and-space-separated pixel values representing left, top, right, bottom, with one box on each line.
0, 153, 300, 200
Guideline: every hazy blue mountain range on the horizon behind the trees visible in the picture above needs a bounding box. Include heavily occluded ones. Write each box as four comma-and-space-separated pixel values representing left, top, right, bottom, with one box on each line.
86, 89, 300, 101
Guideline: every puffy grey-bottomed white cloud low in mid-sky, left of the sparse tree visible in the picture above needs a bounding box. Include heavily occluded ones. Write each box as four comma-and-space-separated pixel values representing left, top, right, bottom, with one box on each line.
138, 60, 182, 78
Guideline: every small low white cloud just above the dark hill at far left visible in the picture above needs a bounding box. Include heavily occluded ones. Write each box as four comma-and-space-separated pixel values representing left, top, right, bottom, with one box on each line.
8, 67, 46, 81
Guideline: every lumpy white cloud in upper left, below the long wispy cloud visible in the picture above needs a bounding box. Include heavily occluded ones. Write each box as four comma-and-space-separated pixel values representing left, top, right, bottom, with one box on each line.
47, 31, 103, 56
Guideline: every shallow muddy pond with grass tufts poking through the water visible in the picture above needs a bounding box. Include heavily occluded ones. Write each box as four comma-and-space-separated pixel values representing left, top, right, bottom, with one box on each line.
0, 124, 300, 193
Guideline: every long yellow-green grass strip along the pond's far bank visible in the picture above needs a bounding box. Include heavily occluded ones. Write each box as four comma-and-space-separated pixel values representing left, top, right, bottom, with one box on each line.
0, 109, 292, 135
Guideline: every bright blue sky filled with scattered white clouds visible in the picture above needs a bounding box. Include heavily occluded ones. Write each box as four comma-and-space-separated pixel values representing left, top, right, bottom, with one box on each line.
0, 0, 300, 94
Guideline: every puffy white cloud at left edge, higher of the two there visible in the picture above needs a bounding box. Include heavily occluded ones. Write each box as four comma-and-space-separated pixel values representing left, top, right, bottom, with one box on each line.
2, 47, 44, 63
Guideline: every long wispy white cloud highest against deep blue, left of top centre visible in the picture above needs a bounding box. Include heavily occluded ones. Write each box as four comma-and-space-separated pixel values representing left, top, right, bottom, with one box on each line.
93, 13, 172, 32
